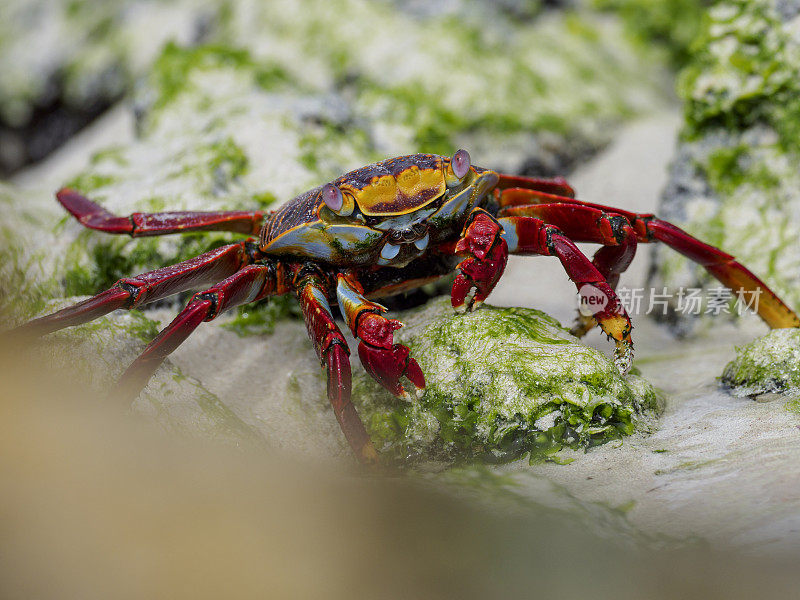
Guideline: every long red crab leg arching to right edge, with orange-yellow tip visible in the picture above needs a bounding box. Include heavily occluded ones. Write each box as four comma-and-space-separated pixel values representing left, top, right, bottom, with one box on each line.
498, 189, 800, 328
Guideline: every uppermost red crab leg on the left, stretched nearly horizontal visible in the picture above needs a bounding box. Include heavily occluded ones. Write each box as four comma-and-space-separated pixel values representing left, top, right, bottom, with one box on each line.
56, 188, 266, 237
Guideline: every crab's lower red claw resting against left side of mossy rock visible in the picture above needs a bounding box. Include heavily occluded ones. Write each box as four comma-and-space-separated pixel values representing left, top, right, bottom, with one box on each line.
357, 312, 425, 400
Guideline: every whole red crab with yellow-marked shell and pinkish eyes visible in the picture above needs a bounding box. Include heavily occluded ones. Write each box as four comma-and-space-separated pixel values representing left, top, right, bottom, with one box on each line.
9, 150, 800, 463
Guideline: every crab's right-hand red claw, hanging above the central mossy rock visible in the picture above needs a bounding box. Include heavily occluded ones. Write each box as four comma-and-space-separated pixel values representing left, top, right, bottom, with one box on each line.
450, 208, 508, 310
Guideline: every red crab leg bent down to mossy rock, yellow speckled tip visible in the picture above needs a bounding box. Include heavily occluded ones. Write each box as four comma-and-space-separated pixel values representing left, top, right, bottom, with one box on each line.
498, 216, 633, 373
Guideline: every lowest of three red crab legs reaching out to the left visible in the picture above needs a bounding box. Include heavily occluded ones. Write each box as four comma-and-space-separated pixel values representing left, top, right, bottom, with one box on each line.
117, 263, 288, 402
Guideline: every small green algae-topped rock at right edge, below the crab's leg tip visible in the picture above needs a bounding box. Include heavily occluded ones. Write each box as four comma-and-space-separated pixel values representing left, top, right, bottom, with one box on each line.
722, 329, 800, 396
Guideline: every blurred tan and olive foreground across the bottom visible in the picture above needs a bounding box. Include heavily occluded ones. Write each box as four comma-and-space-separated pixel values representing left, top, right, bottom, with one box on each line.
0, 342, 800, 599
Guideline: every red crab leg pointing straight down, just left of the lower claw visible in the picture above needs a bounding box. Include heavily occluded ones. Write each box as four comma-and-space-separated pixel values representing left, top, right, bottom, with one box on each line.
295, 273, 378, 464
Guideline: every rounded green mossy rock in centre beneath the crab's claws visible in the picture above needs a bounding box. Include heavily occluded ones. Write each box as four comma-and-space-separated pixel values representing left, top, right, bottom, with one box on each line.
353, 299, 660, 461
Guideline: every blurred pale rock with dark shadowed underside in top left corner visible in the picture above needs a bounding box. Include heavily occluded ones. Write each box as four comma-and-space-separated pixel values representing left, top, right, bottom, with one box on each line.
0, 0, 221, 175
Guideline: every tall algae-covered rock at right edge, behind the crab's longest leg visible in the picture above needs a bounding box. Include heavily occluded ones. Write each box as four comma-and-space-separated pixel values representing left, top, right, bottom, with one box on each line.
651, 0, 800, 331
